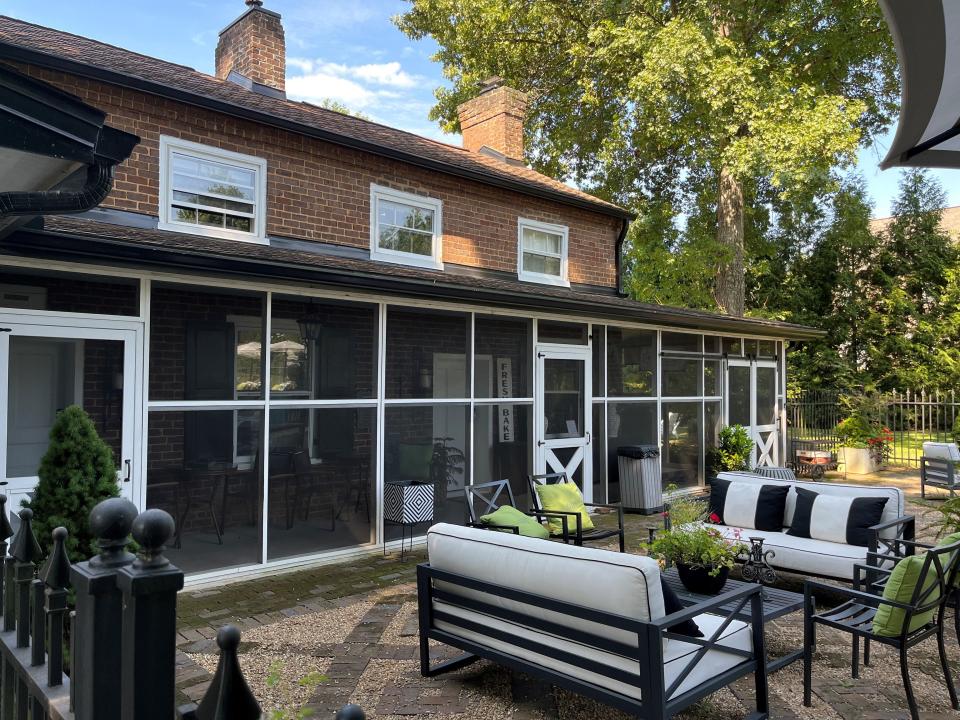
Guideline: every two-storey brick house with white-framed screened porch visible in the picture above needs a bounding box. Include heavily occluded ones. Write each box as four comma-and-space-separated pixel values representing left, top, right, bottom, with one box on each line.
0, 0, 816, 578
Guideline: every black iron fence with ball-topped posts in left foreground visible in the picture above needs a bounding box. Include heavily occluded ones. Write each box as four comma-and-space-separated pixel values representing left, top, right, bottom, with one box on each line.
0, 495, 364, 720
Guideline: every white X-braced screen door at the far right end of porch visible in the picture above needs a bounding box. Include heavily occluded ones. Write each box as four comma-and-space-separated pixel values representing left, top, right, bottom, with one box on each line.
727, 359, 779, 467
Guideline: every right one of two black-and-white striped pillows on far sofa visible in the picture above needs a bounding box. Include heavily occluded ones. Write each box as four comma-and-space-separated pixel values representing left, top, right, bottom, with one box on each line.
787, 488, 888, 547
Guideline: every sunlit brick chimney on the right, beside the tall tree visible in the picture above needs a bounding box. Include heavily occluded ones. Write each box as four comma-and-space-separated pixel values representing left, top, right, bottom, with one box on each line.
457, 78, 527, 161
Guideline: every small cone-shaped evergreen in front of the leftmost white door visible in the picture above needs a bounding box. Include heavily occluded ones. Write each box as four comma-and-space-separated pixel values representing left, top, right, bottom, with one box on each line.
23, 405, 119, 562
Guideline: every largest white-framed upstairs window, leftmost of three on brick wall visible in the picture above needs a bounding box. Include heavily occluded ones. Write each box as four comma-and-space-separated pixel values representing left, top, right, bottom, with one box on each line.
159, 135, 267, 242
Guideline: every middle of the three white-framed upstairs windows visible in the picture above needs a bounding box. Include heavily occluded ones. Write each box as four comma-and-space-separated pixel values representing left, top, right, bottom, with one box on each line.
370, 183, 443, 270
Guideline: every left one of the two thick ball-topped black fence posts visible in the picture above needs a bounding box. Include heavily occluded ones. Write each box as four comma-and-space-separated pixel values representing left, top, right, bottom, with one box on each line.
70, 498, 137, 720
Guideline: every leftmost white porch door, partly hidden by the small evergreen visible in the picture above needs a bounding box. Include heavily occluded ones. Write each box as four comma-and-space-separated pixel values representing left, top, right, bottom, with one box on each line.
0, 315, 138, 512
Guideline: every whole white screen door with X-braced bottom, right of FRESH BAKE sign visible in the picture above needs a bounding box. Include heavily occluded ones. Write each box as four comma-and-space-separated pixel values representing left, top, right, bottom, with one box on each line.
535, 345, 593, 502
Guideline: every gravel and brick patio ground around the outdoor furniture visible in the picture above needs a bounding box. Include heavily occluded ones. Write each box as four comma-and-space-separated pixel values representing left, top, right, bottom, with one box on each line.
177, 472, 960, 720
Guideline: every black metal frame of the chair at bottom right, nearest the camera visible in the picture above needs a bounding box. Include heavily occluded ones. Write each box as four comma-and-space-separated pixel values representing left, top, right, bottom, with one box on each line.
803, 542, 960, 720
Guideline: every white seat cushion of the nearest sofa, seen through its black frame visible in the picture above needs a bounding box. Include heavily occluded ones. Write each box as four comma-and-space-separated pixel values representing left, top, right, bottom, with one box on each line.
434, 593, 751, 700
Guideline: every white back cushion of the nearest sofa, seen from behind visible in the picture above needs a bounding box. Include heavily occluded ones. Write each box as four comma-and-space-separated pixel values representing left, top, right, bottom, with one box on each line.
427, 523, 664, 647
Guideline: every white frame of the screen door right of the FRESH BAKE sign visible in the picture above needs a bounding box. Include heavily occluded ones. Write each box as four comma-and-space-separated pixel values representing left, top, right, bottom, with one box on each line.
533, 343, 593, 502
